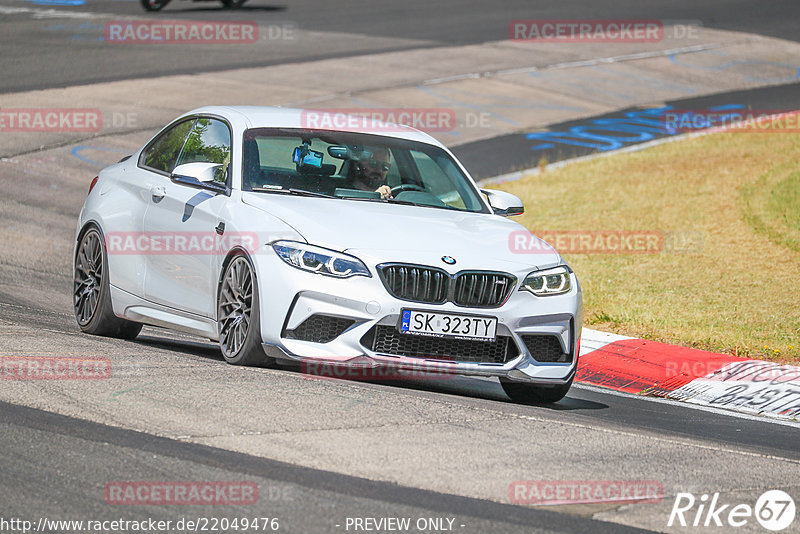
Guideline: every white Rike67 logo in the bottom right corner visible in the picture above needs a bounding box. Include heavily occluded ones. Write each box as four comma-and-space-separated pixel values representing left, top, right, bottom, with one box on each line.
667, 490, 795, 532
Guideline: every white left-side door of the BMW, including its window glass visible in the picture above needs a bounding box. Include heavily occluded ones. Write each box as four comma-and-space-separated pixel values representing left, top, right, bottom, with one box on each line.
144, 117, 231, 318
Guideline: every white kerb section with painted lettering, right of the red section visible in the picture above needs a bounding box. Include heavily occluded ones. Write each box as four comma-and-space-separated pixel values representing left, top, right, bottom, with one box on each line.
667, 360, 800, 420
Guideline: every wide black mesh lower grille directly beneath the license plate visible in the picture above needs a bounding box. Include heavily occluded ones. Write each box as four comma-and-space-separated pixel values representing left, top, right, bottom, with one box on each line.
361, 325, 518, 363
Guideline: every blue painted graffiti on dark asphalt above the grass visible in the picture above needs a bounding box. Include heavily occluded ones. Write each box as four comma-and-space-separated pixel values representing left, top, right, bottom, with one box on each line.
525, 104, 745, 152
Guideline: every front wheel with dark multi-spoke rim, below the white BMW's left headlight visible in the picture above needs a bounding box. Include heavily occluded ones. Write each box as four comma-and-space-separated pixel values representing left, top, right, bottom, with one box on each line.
217, 253, 276, 367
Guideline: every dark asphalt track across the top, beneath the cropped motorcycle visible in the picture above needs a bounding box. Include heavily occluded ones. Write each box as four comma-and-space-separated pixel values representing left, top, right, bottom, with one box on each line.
0, 0, 800, 93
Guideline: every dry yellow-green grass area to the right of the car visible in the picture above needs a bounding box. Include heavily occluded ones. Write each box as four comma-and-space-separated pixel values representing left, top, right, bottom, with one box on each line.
499, 129, 800, 363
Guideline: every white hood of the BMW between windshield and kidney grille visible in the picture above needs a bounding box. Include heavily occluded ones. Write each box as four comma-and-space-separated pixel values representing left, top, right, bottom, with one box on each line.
242, 192, 561, 271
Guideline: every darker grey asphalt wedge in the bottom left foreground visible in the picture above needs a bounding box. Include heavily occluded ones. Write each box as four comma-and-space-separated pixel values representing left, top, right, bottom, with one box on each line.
0, 403, 648, 533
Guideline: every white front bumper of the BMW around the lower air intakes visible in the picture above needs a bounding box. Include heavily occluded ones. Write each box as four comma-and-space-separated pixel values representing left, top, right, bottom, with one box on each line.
256, 253, 583, 385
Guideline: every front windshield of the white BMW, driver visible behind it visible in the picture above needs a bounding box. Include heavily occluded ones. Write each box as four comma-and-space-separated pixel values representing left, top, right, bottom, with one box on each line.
242, 128, 488, 212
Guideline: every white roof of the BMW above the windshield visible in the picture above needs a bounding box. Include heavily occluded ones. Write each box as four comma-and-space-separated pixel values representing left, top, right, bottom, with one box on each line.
183, 106, 444, 148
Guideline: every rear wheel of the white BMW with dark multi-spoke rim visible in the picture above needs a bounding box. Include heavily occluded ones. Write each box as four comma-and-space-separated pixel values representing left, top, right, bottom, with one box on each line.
72, 226, 142, 339
